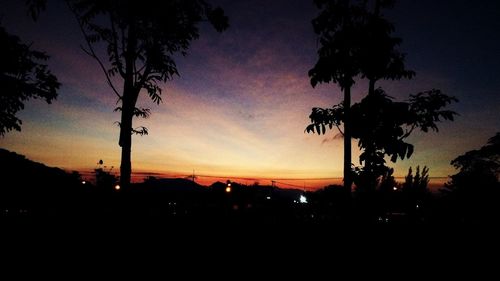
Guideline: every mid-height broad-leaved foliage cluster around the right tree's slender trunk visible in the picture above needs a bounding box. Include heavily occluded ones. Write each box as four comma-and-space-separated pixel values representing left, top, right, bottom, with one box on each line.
306, 88, 457, 175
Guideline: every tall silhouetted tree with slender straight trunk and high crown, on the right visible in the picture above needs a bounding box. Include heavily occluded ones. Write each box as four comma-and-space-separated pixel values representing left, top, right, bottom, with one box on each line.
306, 0, 415, 189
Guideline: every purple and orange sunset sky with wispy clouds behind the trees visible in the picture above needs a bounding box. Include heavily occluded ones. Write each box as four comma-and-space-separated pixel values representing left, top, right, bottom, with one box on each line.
0, 0, 500, 187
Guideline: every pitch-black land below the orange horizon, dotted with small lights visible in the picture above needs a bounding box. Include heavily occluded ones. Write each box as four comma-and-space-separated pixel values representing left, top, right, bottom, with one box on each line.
0, 148, 500, 270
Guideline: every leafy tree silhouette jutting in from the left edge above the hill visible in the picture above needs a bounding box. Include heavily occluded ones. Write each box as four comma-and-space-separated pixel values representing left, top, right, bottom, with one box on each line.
0, 23, 60, 136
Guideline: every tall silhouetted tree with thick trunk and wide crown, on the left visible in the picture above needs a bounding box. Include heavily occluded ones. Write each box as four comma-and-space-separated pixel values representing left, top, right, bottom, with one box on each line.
62, 0, 228, 186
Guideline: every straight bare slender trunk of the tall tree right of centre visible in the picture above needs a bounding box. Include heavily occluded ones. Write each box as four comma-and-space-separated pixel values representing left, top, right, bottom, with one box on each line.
344, 86, 352, 192
